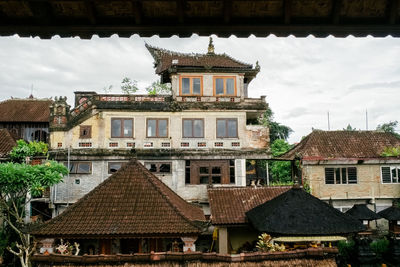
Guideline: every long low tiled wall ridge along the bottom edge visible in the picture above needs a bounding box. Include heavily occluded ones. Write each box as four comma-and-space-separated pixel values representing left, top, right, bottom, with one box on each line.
32, 247, 339, 267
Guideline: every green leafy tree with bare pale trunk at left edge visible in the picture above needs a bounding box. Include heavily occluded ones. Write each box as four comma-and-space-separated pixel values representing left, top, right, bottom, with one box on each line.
0, 142, 68, 267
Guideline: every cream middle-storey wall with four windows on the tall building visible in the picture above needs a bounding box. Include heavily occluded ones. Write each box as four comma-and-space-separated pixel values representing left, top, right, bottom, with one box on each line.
50, 111, 268, 152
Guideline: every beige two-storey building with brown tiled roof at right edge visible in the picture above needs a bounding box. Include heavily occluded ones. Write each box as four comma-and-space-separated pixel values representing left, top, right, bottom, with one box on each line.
281, 130, 400, 217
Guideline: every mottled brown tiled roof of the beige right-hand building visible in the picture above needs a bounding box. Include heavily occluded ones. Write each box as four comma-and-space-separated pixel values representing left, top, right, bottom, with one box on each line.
280, 130, 400, 160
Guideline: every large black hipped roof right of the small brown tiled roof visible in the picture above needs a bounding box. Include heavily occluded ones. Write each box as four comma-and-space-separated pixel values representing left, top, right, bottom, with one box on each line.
246, 187, 365, 236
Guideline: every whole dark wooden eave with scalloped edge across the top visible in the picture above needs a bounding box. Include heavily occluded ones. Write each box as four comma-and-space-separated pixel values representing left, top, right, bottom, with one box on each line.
0, 0, 400, 39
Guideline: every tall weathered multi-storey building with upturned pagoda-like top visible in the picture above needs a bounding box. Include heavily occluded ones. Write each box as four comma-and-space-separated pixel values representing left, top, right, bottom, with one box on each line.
50, 40, 269, 214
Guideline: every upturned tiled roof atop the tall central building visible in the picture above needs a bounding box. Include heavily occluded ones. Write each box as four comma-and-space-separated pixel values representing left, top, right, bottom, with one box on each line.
146, 44, 253, 74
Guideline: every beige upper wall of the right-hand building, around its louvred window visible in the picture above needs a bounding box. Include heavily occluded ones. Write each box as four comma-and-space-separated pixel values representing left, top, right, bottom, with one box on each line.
303, 164, 400, 200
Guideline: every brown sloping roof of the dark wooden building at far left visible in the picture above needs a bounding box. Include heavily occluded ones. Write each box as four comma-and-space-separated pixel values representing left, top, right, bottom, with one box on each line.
0, 99, 52, 122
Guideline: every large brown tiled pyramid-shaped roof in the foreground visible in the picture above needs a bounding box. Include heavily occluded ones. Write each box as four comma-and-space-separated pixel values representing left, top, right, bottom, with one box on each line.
33, 160, 205, 238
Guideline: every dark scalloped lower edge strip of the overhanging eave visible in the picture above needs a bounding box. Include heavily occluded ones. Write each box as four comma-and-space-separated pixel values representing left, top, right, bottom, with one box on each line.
0, 23, 400, 38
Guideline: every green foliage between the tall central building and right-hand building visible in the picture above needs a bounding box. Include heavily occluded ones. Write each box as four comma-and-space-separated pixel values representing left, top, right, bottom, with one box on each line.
269, 139, 292, 184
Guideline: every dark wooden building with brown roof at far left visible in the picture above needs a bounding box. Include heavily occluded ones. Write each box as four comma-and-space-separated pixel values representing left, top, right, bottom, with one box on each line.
0, 96, 52, 142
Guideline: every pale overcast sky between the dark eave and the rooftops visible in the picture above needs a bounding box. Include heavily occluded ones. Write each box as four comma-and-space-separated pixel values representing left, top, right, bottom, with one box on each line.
0, 36, 400, 143
